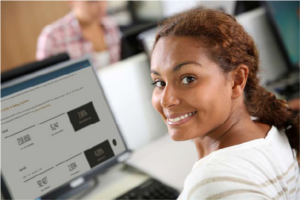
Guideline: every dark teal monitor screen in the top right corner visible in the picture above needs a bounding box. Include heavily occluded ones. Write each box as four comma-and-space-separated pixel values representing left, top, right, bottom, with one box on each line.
261, 0, 300, 70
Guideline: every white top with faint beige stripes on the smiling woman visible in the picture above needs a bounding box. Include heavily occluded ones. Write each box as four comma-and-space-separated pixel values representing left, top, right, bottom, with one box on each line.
178, 126, 300, 200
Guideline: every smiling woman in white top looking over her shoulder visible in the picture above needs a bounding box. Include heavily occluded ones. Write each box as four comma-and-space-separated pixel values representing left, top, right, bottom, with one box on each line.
151, 8, 300, 200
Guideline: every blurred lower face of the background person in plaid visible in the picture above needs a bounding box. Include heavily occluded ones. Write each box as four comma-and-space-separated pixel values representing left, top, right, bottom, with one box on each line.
71, 0, 107, 22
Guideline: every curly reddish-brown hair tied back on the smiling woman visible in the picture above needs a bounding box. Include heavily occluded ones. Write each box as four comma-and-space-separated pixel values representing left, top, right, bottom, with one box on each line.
153, 7, 300, 160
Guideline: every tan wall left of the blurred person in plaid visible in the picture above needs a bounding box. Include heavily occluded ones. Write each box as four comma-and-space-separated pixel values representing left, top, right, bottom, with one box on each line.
0, 0, 69, 72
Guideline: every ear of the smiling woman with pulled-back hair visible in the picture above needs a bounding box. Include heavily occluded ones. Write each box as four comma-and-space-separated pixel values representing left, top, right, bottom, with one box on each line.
230, 64, 249, 99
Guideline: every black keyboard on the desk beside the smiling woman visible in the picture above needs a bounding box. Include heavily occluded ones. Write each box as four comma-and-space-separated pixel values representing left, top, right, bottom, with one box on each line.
115, 179, 179, 200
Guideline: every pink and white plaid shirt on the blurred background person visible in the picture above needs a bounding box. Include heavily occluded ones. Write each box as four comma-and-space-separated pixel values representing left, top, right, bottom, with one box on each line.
36, 12, 121, 64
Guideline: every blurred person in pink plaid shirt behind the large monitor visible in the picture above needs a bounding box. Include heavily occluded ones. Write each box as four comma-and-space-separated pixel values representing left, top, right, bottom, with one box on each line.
36, 0, 120, 68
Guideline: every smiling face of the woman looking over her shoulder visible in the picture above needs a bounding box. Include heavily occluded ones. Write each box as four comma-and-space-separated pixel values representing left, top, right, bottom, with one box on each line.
151, 37, 233, 141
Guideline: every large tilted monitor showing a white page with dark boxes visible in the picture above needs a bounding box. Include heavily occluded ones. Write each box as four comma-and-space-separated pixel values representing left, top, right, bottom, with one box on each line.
0, 58, 128, 200
